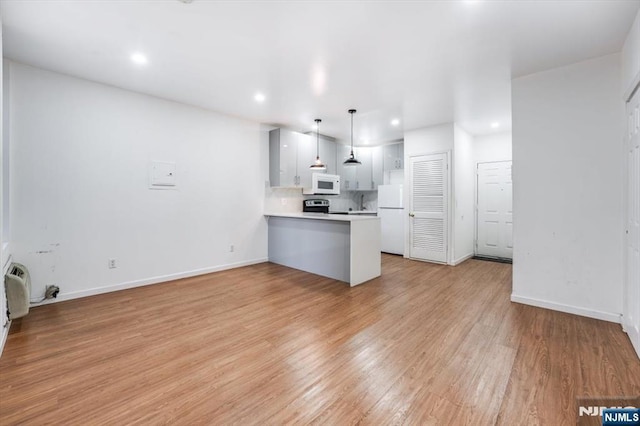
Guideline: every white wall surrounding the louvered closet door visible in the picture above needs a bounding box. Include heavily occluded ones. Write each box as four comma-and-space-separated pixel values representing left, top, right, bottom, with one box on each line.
404, 123, 454, 262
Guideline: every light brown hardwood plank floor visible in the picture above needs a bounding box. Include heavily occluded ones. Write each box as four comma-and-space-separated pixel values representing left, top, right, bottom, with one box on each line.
0, 255, 640, 425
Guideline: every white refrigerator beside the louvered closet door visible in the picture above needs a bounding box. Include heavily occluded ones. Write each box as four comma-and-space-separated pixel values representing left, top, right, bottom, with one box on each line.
378, 185, 404, 255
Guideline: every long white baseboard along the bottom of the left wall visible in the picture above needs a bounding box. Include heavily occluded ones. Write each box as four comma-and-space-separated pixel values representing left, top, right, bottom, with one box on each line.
31, 257, 269, 306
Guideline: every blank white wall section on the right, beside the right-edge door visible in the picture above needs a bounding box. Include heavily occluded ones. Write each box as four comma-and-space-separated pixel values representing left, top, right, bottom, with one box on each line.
512, 54, 624, 321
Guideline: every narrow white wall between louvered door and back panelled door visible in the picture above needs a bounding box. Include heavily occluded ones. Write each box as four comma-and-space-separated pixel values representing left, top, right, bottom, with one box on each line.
453, 125, 476, 264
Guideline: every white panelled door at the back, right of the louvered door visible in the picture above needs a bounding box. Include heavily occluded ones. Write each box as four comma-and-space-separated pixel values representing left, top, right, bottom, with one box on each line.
476, 161, 513, 259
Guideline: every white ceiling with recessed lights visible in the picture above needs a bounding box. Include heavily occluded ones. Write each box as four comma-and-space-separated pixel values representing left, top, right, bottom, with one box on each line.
0, 0, 640, 145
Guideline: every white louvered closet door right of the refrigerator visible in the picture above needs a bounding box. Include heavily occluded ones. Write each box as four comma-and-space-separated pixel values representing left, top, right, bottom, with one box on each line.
409, 154, 449, 263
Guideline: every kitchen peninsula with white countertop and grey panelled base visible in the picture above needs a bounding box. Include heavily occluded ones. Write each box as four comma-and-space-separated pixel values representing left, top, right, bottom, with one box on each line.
265, 213, 381, 287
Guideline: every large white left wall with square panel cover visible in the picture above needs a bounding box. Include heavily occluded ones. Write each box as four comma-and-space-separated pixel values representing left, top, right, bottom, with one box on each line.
10, 63, 268, 299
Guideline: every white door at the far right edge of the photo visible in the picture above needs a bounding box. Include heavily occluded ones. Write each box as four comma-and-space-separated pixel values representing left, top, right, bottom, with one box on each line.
623, 88, 640, 356
